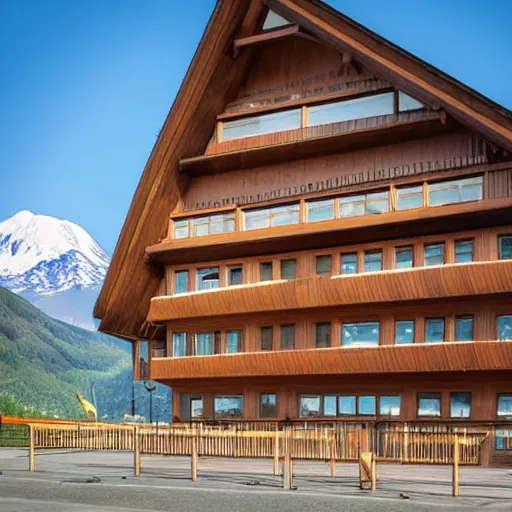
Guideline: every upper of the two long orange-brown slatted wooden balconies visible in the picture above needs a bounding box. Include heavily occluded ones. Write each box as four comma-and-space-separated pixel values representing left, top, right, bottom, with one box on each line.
148, 260, 512, 323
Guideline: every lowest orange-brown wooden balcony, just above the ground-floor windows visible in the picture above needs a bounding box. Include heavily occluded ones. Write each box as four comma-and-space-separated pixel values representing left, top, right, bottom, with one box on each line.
151, 341, 512, 384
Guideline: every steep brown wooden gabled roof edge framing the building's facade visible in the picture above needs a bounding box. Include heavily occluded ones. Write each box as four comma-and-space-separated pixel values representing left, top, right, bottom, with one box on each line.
94, 0, 512, 339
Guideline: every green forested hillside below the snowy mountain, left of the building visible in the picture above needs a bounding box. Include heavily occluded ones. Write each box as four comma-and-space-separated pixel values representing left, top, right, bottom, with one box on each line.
0, 288, 170, 421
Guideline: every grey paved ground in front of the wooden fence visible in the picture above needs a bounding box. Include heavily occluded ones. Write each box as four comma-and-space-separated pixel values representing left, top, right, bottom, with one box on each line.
0, 449, 512, 512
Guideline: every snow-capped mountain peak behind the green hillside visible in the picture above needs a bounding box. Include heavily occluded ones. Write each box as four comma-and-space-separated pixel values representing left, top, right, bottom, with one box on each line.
0, 211, 110, 328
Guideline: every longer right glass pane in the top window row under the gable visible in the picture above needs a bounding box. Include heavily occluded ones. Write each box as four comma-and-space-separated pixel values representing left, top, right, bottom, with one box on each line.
308, 92, 394, 126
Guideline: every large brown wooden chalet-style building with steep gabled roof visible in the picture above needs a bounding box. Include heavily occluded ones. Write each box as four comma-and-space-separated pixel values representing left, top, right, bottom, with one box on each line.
95, 0, 512, 464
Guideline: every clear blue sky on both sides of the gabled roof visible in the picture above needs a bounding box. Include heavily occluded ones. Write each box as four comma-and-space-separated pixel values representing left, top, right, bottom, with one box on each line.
0, 0, 512, 253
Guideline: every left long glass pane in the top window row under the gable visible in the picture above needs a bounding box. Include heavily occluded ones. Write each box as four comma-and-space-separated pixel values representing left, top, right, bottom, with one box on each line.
222, 109, 301, 141
